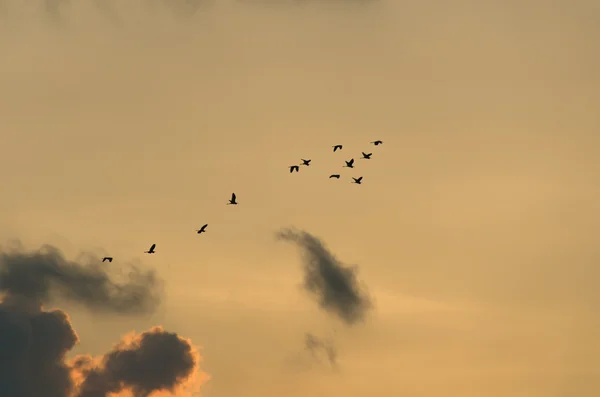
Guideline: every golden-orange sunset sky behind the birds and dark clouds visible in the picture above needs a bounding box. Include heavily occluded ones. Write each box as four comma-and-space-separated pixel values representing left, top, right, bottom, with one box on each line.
0, 0, 600, 397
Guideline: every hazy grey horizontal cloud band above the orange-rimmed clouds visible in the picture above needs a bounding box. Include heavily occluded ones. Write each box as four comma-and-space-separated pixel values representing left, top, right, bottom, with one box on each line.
0, 246, 162, 314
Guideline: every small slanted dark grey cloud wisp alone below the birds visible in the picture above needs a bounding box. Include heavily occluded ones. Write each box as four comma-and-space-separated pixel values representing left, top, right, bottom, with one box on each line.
277, 229, 373, 325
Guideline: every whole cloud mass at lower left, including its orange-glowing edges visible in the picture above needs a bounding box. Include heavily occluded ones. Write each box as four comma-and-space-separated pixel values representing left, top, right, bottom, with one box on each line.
0, 241, 205, 397
